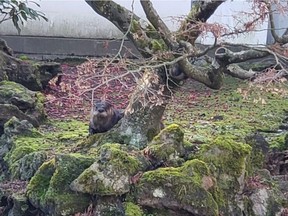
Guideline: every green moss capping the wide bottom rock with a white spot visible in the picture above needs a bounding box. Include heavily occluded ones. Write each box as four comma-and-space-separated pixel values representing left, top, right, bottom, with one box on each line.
137, 168, 219, 215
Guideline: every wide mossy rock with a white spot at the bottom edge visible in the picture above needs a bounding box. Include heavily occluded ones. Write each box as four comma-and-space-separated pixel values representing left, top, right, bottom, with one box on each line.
136, 162, 219, 216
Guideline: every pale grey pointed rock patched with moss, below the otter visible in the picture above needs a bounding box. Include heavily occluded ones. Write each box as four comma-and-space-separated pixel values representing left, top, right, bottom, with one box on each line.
71, 143, 141, 196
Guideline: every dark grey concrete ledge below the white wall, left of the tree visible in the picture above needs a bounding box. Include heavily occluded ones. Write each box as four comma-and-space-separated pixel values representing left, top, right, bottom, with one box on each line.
0, 35, 140, 58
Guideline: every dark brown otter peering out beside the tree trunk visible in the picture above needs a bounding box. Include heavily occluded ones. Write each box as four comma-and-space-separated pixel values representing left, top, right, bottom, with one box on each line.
89, 101, 124, 135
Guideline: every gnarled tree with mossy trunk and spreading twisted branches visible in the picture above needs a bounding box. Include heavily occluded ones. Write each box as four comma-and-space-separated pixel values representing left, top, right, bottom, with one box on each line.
86, 0, 288, 148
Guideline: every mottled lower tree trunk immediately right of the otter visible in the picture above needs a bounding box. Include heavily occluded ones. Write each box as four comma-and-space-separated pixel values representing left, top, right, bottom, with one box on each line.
120, 71, 170, 149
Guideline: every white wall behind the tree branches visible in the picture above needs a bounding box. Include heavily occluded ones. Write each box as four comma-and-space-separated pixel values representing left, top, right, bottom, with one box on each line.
0, 0, 276, 44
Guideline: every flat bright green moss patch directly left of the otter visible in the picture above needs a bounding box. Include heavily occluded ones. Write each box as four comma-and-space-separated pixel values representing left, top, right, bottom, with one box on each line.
4, 119, 88, 182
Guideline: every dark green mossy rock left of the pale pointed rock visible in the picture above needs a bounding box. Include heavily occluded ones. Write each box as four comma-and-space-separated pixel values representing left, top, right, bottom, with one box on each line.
27, 154, 93, 215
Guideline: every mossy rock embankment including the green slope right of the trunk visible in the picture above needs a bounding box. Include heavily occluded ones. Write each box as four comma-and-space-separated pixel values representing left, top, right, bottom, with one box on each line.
0, 75, 288, 216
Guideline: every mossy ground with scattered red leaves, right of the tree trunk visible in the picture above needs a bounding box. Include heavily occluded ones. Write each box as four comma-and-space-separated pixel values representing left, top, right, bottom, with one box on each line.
164, 77, 288, 148
